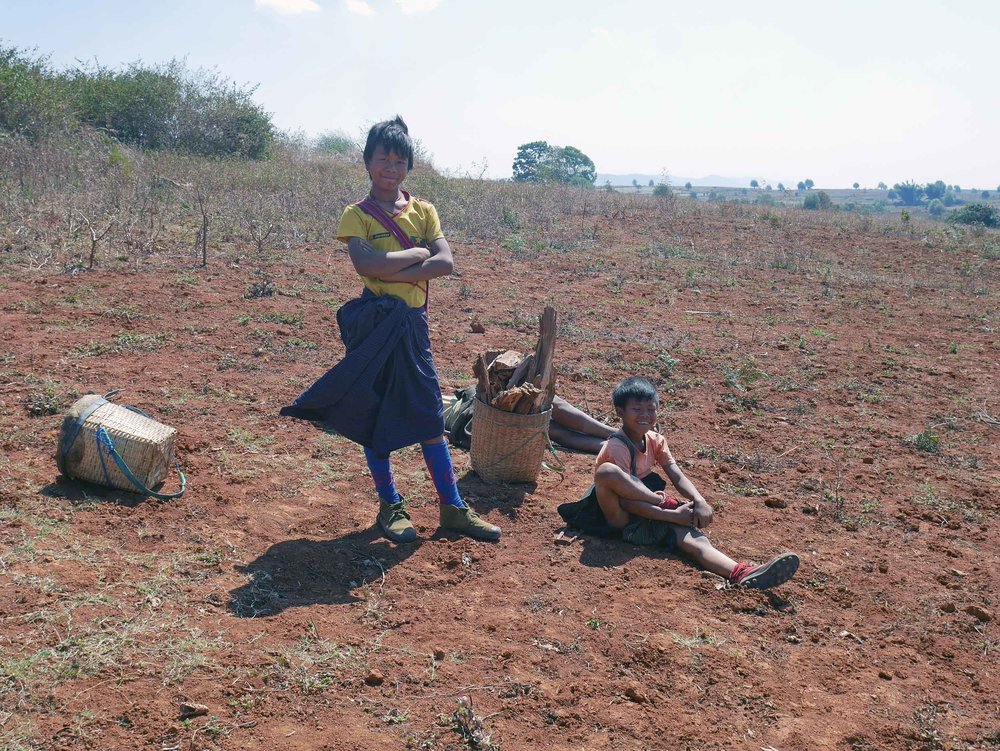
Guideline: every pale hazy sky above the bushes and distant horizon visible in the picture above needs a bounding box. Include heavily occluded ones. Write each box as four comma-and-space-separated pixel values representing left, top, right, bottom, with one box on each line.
0, 0, 1000, 190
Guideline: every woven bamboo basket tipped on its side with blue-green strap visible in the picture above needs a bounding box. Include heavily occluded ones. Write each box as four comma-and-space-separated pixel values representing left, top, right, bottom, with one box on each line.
57, 394, 177, 492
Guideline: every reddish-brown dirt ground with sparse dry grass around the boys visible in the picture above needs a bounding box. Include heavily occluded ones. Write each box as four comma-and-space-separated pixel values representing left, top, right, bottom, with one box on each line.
0, 207, 1000, 751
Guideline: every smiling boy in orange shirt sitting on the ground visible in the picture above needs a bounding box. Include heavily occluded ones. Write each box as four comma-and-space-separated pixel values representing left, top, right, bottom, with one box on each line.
580, 378, 799, 589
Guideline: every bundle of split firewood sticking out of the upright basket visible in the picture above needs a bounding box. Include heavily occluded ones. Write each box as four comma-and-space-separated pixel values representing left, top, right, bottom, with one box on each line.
472, 308, 556, 415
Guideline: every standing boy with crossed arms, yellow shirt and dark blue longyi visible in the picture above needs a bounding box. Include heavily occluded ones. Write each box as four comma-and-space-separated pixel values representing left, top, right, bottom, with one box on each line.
281, 116, 500, 542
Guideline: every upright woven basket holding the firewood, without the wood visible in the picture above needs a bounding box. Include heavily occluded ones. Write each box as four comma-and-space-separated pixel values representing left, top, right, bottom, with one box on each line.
469, 399, 552, 483
